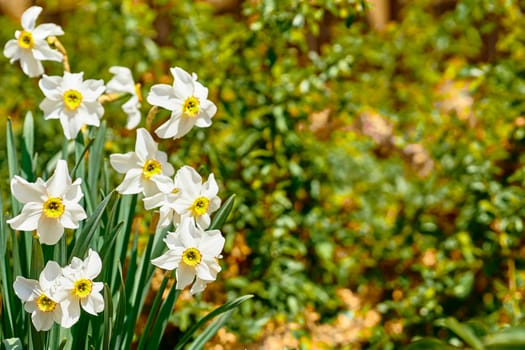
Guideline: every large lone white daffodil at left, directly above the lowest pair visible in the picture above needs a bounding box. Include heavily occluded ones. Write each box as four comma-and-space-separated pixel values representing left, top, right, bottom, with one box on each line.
7, 160, 87, 244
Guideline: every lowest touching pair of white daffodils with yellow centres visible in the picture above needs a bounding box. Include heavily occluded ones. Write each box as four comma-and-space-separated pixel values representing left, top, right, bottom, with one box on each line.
14, 249, 104, 331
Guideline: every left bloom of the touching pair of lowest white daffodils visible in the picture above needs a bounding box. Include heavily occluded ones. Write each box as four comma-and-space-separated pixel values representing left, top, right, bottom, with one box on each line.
13, 261, 69, 331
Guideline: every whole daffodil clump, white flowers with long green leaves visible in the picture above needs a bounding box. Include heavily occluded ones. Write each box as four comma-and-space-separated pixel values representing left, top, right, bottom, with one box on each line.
0, 6, 249, 349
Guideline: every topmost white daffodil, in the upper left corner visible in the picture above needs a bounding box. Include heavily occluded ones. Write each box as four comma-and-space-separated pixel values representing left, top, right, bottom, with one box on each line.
4, 6, 64, 77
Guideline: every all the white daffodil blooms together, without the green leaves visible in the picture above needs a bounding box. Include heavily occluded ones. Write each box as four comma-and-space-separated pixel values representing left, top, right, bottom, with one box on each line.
4, 6, 228, 330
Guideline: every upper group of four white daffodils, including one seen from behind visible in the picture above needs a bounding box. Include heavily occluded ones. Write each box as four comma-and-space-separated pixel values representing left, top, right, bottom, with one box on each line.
4, 6, 217, 139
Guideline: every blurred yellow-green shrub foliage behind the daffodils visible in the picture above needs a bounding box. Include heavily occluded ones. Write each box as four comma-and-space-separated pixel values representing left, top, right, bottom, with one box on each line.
0, 0, 525, 349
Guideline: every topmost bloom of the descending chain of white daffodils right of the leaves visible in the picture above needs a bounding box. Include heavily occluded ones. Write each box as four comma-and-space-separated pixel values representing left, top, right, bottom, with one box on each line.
109, 128, 175, 197
